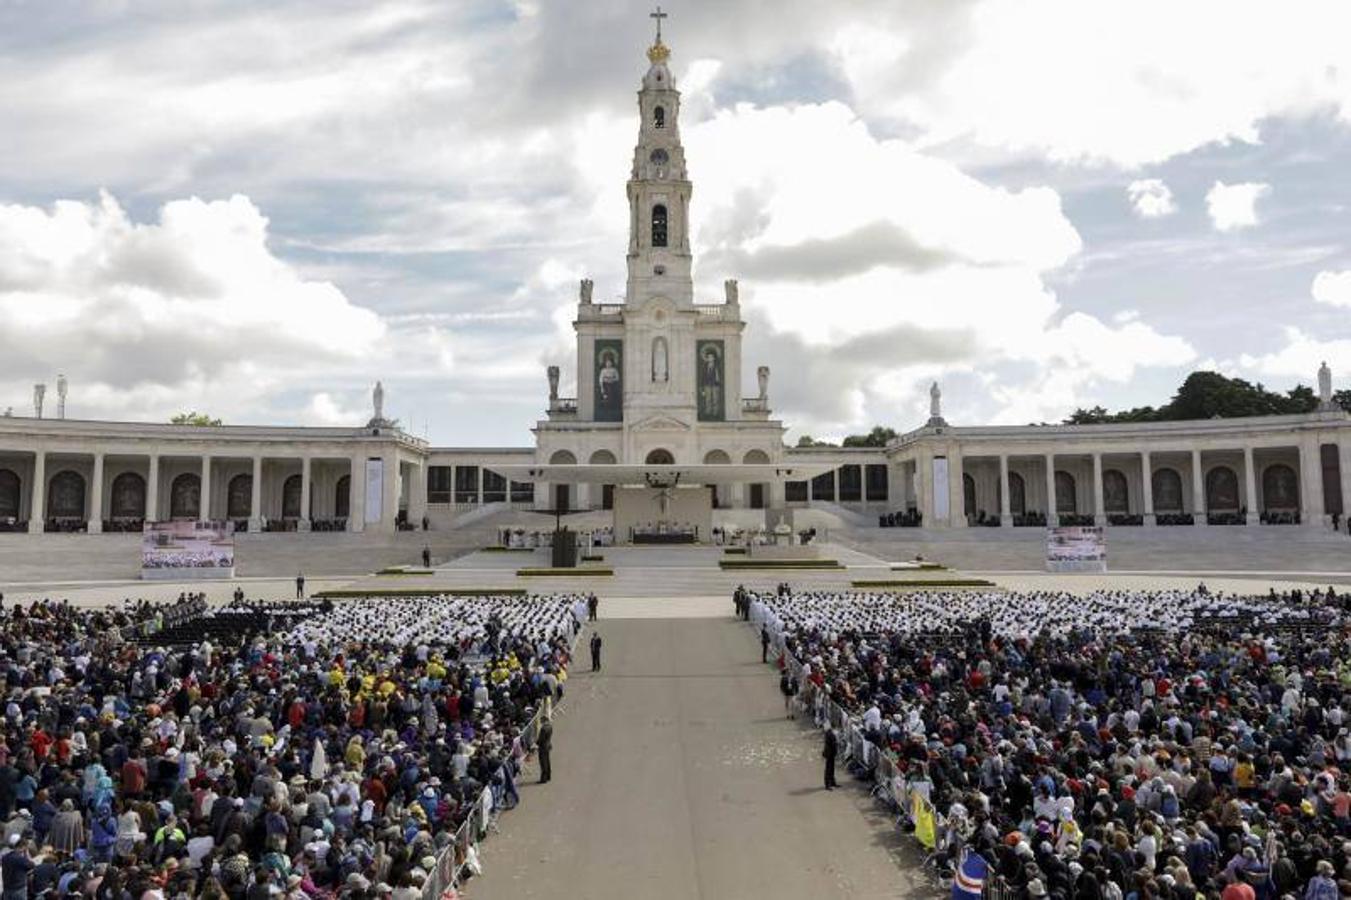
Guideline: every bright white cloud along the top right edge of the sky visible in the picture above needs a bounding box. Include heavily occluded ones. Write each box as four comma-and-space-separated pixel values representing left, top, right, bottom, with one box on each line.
838, 0, 1351, 166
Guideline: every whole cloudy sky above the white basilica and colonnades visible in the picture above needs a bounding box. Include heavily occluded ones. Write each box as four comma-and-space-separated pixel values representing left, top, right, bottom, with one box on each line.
0, 0, 1351, 446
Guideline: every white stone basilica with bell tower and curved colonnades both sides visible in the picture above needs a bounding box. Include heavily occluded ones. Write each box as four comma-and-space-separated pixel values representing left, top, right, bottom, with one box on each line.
0, 36, 1351, 534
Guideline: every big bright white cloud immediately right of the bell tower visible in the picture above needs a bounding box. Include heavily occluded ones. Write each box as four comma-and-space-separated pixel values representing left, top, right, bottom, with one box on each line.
664, 103, 1196, 434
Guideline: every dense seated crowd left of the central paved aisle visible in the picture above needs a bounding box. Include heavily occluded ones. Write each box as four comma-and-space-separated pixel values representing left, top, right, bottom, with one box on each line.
0, 596, 586, 900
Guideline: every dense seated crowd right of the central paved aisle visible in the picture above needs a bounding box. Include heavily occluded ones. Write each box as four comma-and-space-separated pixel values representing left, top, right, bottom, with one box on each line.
738, 585, 1351, 900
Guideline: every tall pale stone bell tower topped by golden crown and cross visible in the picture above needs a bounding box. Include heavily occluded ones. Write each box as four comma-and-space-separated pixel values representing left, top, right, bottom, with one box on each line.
626, 7, 694, 307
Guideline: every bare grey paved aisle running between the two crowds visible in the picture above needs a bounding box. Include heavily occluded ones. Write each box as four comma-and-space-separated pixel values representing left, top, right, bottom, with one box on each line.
466, 616, 936, 900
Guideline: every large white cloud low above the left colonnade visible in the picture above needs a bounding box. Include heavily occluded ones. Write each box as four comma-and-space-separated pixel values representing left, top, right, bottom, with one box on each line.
0, 187, 464, 424
